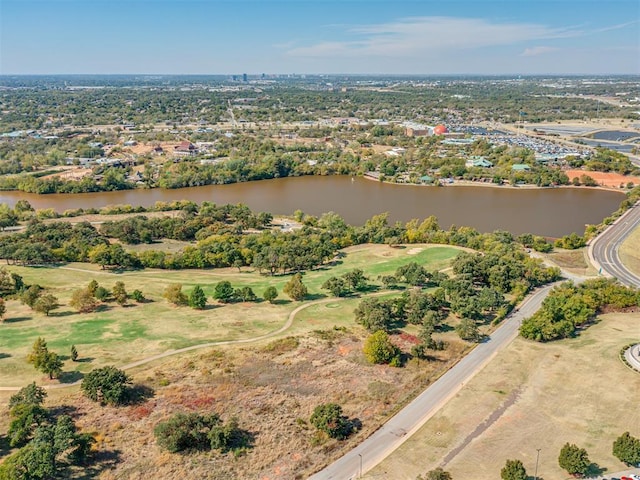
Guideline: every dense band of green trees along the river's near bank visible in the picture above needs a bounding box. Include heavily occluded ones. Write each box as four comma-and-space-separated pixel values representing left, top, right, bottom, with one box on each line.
0, 202, 568, 274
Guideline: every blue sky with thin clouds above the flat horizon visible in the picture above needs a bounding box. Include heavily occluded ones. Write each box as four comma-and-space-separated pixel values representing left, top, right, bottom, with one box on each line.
0, 0, 640, 74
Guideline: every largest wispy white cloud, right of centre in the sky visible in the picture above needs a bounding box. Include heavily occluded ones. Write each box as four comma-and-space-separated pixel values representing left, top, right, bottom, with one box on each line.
287, 17, 584, 57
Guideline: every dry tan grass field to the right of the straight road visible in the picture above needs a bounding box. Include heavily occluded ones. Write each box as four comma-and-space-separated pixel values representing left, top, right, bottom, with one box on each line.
365, 314, 640, 480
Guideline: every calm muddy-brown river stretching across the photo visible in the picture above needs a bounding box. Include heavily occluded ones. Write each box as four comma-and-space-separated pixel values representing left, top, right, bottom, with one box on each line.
0, 176, 624, 237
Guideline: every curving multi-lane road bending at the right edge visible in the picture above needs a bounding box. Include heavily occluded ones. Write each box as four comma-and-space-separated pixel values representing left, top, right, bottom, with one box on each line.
589, 204, 640, 287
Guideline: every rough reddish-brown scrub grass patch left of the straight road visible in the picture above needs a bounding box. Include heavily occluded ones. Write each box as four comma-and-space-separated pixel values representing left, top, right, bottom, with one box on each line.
0, 327, 472, 479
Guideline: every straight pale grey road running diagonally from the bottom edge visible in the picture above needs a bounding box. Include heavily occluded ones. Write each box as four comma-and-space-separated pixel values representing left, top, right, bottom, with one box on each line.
310, 284, 555, 480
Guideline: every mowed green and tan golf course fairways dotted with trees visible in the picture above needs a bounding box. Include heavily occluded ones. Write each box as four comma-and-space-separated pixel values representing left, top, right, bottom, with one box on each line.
0, 245, 459, 386
